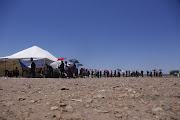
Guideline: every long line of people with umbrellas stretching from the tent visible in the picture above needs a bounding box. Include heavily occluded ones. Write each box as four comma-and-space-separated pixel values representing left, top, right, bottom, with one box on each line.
14, 58, 163, 78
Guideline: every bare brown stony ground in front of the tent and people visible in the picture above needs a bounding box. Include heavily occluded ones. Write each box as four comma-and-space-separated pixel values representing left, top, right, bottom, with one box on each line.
0, 77, 180, 120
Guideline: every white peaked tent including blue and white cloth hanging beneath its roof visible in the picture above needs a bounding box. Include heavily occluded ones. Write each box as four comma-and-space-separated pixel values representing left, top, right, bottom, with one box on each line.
0, 46, 57, 68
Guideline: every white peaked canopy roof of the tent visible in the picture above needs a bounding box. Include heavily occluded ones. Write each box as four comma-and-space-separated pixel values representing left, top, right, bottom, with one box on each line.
1, 46, 57, 61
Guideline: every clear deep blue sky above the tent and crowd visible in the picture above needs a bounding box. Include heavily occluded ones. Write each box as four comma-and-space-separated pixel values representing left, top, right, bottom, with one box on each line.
0, 0, 180, 73
